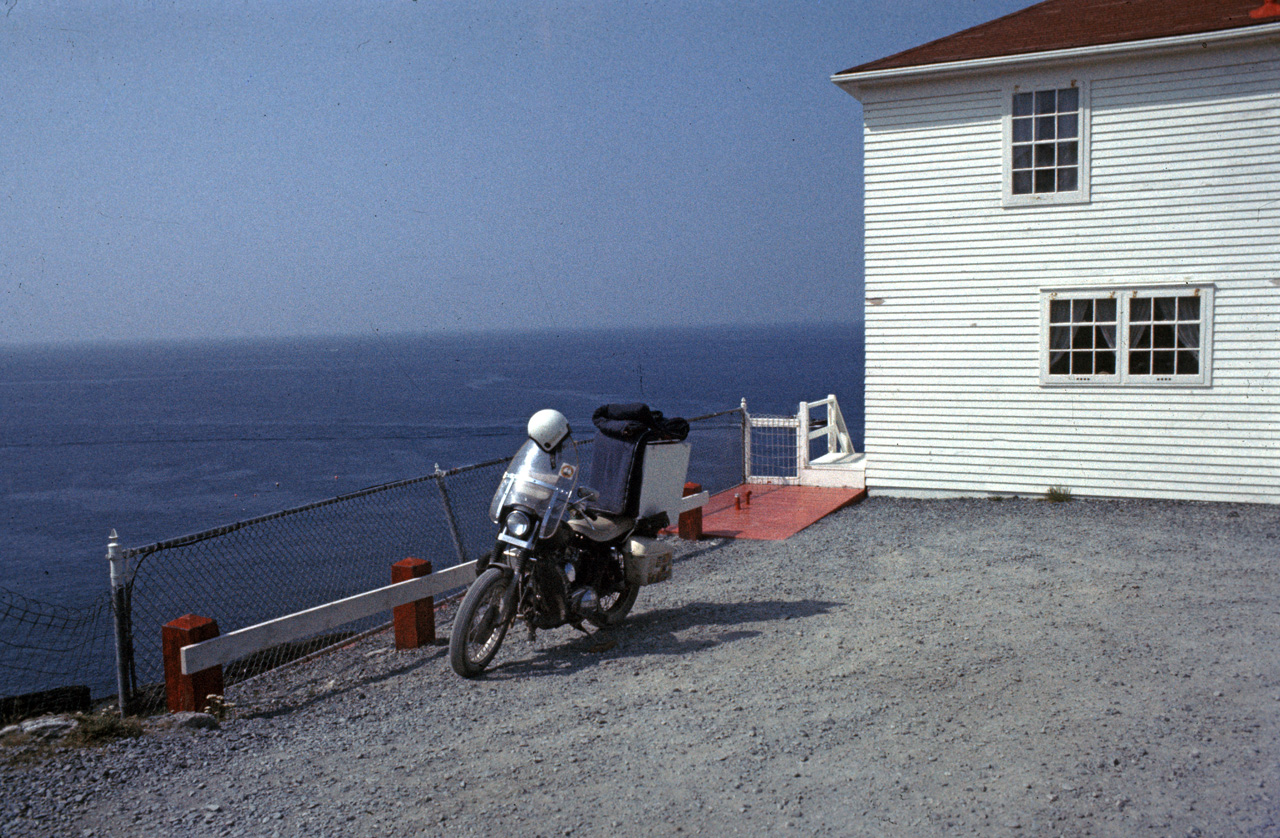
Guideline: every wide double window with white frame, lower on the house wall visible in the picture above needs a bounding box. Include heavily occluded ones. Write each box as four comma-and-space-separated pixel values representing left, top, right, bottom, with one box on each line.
1041, 284, 1213, 386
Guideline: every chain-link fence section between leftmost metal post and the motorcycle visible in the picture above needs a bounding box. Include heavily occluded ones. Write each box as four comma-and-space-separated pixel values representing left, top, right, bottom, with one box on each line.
122, 461, 506, 711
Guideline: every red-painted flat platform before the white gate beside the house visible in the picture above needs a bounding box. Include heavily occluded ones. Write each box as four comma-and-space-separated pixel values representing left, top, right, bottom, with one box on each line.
675, 484, 867, 541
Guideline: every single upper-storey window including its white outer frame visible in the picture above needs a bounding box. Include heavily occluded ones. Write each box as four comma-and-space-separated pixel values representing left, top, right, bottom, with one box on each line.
1004, 79, 1089, 206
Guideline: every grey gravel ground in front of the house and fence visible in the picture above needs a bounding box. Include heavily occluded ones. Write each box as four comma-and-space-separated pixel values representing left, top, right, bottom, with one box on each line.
0, 498, 1280, 837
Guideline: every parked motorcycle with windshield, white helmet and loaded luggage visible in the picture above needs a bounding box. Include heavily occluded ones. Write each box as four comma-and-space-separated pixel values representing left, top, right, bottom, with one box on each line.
449, 406, 705, 678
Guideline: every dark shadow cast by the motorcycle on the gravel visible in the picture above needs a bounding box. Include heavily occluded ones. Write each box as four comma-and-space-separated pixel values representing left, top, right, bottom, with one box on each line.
485, 600, 844, 679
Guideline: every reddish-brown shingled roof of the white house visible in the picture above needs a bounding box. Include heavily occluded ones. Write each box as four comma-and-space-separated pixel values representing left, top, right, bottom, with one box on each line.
840, 0, 1280, 75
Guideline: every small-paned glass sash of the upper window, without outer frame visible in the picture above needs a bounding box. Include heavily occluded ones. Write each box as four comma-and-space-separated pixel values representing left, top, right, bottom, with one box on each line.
1010, 87, 1080, 194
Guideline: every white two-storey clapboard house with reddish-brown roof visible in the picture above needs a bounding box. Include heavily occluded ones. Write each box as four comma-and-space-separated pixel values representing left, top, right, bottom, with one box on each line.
832, 0, 1280, 503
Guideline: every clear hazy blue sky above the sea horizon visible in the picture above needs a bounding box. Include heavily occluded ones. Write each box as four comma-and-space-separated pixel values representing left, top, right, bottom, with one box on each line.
0, 0, 1029, 344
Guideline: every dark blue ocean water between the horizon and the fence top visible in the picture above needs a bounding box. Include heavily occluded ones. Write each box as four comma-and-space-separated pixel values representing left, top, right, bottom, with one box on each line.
0, 324, 863, 606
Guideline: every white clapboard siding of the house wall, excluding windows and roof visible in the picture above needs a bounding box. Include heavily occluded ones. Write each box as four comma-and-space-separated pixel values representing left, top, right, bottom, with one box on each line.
864, 45, 1280, 503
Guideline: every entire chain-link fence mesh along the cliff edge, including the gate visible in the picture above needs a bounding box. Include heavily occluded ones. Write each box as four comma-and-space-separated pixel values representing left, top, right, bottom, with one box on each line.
0, 408, 745, 714
